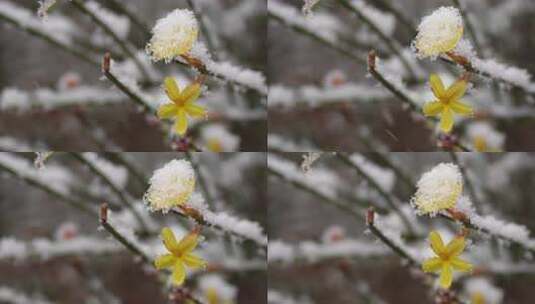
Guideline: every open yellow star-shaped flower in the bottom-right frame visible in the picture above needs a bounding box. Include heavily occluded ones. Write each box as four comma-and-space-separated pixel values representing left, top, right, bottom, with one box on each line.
422, 231, 472, 289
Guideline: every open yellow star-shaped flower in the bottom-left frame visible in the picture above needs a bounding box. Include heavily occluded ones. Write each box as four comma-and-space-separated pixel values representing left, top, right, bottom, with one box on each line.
154, 227, 206, 285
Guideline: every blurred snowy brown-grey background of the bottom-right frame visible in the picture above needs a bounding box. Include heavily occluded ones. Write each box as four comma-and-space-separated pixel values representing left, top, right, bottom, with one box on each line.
268, 152, 535, 304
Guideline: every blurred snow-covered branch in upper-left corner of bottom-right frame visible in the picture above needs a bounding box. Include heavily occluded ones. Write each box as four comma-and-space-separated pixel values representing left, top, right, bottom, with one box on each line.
268, 154, 341, 198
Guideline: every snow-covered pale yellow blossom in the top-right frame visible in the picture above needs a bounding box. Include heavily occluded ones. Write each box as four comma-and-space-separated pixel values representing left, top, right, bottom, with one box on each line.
414, 7, 464, 58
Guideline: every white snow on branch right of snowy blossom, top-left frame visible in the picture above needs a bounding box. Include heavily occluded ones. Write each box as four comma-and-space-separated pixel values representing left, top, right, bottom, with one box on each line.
190, 42, 267, 94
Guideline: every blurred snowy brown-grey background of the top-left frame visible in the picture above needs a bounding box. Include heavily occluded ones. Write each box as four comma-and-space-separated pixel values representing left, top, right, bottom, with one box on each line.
0, 0, 267, 151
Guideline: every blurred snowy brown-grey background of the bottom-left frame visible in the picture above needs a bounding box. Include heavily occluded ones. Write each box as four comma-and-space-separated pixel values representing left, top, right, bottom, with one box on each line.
0, 152, 267, 304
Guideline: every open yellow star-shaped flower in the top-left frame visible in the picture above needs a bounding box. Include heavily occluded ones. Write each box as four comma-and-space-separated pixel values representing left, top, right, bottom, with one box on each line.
158, 77, 206, 135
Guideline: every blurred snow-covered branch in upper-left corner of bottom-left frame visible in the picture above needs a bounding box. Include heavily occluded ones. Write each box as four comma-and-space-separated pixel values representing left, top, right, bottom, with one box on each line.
0, 152, 75, 194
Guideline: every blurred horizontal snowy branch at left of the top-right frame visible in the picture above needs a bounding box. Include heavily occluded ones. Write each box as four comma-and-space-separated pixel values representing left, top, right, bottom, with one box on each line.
268, 83, 390, 108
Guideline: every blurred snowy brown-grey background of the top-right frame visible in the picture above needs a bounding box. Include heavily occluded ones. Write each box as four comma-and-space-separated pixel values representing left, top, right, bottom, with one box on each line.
268, 0, 535, 152
